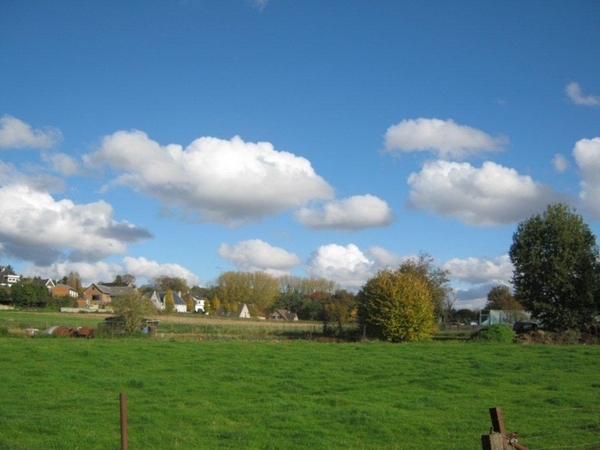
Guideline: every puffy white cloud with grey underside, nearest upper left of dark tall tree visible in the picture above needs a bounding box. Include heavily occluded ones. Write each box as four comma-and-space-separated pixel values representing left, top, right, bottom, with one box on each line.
408, 160, 569, 226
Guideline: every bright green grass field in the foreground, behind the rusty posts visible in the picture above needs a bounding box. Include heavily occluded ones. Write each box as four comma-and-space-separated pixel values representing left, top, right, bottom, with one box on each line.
0, 338, 600, 450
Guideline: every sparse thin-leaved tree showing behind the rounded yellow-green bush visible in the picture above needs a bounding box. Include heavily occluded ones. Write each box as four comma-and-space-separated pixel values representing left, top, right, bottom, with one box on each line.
398, 253, 454, 321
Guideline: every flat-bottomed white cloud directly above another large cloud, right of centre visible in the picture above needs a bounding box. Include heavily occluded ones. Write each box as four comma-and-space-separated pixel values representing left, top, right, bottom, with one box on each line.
385, 118, 508, 159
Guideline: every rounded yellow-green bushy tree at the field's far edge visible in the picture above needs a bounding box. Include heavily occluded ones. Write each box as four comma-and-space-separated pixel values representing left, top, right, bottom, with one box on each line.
357, 269, 435, 342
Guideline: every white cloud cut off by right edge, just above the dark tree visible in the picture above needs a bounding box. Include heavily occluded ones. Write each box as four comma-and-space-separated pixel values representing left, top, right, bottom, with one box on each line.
573, 137, 600, 218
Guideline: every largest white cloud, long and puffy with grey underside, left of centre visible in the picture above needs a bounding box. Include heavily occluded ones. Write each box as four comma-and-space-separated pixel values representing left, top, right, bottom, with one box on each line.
83, 130, 333, 226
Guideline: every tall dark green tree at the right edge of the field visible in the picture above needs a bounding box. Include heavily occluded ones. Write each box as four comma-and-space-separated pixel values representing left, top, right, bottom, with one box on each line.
509, 204, 600, 331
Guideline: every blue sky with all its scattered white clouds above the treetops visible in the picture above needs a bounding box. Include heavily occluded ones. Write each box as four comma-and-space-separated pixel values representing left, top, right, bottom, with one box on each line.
0, 0, 600, 307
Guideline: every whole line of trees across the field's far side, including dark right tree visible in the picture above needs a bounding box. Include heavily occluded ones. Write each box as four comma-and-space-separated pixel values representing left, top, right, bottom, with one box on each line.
0, 204, 600, 341
